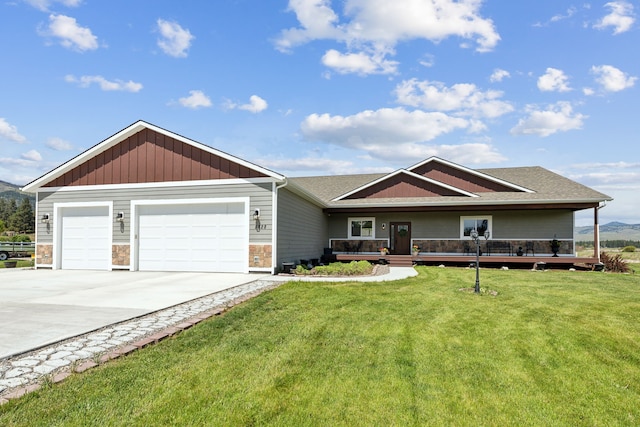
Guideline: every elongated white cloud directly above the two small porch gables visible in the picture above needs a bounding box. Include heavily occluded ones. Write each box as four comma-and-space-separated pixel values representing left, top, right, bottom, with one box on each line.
395, 79, 513, 118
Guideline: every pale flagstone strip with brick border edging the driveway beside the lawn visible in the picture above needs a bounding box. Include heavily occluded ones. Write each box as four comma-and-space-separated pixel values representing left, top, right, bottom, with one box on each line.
0, 280, 286, 405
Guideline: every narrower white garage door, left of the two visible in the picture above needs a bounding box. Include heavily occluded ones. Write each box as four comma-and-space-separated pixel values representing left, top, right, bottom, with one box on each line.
60, 206, 111, 270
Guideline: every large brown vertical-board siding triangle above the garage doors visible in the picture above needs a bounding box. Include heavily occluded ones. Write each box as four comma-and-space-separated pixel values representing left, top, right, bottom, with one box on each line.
45, 129, 266, 187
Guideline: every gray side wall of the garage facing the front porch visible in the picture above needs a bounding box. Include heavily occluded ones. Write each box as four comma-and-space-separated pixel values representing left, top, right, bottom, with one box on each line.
276, 188, 328, 267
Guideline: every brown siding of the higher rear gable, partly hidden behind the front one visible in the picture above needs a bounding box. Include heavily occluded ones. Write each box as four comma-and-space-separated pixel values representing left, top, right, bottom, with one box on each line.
411, 162, 517, 193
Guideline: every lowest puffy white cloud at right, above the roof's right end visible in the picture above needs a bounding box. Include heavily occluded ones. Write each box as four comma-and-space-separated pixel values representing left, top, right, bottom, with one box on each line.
511, 101, 587, 137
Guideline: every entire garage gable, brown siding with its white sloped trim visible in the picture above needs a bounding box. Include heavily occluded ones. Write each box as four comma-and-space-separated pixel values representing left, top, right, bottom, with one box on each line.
23, 120, 285, 191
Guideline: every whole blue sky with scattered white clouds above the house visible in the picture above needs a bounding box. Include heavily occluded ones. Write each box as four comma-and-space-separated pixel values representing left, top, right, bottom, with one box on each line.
0, 0, 640, 225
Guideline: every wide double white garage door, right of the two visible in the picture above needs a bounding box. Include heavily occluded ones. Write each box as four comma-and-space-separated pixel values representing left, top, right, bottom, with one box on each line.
138, 203, 249, 272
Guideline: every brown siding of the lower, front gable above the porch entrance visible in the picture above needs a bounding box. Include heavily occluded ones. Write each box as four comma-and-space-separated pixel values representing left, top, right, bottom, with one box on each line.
345, 174, 460, 200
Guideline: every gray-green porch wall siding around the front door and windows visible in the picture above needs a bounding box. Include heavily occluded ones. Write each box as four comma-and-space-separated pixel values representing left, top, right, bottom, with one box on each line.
329, 209, 574, 240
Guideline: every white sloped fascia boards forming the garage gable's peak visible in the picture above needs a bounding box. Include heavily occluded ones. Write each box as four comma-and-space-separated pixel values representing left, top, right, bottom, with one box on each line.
21, 120, 285, 192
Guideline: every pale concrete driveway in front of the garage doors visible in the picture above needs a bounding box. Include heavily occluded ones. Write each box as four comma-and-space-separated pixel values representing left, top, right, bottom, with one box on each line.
0, 269, 270, 359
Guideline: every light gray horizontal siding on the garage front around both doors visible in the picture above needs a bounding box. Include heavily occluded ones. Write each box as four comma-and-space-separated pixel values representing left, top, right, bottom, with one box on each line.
36, 183, 273, 244
